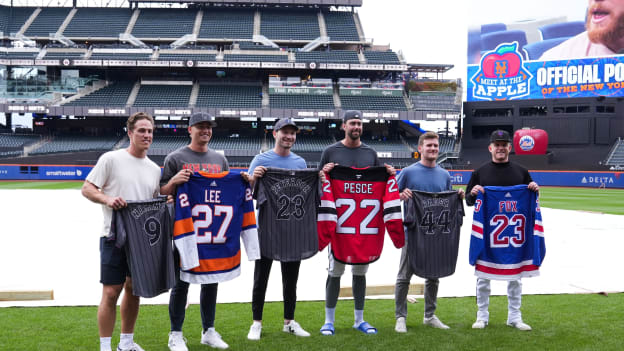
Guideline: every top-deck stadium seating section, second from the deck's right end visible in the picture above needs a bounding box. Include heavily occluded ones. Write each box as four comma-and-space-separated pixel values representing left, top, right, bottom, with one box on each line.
260, 10, 321, 41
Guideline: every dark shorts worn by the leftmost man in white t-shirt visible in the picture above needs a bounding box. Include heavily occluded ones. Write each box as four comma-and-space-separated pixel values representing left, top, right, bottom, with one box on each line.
100, 237, 130, 285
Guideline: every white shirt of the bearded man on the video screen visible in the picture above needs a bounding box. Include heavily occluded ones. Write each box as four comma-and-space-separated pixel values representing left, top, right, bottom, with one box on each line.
539, 31, 615, 61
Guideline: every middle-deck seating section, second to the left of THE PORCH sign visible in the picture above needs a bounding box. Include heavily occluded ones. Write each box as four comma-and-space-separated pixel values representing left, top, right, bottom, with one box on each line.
133, 85, 192, 107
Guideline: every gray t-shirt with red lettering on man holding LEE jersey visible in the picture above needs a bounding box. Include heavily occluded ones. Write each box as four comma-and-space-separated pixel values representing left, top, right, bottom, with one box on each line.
160, 146, 230, 186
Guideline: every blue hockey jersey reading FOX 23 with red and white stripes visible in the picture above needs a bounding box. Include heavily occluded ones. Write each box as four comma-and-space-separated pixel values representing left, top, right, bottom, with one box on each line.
469, 185, 546, 280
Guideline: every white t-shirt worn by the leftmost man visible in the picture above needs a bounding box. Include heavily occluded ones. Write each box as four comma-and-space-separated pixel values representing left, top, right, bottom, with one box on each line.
87, 149, 160, 236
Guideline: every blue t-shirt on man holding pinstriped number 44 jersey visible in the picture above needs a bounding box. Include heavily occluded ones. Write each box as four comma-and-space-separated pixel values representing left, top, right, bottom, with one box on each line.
398, 162, 452, 193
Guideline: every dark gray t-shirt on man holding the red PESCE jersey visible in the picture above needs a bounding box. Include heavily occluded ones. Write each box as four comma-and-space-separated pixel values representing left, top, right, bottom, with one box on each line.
319, 141, 382, 169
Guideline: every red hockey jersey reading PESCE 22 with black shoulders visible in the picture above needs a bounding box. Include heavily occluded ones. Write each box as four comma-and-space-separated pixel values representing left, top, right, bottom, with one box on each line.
317, 166, 405, 264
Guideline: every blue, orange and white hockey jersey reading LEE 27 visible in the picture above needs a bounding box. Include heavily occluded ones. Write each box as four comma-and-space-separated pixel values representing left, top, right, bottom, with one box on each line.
173, 171, 260, 284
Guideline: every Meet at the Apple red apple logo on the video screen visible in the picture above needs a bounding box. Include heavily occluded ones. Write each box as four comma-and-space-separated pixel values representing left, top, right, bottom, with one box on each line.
470, 42, 533, 101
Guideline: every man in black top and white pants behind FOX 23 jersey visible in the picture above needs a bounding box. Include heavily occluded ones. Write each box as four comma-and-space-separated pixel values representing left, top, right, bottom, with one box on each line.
466, 130, 539, 331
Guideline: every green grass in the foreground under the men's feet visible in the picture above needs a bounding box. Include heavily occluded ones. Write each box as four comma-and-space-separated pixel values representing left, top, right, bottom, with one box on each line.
0, 292, 624, 351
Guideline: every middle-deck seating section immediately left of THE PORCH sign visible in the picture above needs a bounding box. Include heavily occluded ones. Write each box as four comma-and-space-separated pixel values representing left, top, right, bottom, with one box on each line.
195, 83, 262, 108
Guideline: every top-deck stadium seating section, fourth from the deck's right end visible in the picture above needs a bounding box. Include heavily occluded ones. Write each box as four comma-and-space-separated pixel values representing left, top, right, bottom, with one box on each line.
132, 8, 197, 38
